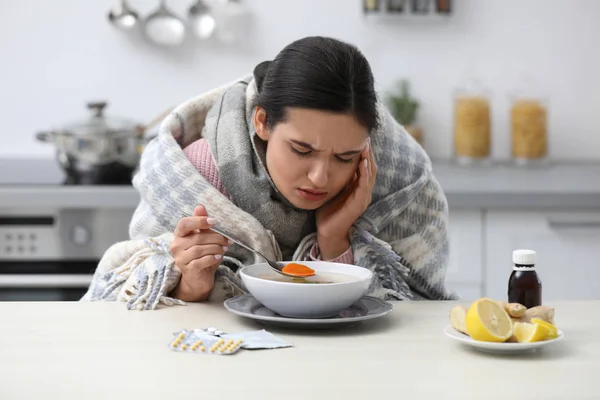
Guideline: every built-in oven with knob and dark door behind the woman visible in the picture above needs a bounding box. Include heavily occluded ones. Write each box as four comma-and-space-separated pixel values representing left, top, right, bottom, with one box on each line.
0, 208, 133, 301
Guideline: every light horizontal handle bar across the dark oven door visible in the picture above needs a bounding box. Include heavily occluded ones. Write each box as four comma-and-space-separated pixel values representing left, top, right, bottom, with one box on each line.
0, 274, 93, 289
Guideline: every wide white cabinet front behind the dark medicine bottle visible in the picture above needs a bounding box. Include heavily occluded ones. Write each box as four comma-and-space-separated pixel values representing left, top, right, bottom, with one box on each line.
483, 209, 600, 303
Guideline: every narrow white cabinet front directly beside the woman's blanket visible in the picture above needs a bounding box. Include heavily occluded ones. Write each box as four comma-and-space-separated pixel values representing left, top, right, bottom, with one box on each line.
446, 210, 483, 300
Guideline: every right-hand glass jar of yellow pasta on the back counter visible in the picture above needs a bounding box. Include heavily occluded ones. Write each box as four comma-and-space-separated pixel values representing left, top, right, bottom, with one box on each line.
510, 79, 548, 165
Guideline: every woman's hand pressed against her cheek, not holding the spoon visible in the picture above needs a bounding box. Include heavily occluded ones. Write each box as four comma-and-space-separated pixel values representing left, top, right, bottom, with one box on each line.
316, 139, 377, 259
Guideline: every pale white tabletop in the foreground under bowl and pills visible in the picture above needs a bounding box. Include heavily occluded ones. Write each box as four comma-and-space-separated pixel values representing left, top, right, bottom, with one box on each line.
0, 302, 600, 400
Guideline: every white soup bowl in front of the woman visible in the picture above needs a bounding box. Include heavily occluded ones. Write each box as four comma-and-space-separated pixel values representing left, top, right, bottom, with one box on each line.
240, 261, 373, 318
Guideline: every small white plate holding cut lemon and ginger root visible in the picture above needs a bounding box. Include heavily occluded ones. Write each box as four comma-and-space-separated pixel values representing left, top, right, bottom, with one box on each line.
444, 297, 564, 353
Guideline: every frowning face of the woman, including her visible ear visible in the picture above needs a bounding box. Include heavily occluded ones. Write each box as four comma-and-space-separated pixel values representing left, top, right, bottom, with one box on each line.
254, 107, 369, 210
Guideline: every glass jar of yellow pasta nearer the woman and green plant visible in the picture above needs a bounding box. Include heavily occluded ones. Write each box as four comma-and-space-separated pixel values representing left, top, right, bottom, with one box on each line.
454, 79, 492, 164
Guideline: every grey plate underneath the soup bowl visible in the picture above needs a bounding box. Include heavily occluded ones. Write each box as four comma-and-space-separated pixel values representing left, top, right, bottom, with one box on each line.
223, 294, 393, 329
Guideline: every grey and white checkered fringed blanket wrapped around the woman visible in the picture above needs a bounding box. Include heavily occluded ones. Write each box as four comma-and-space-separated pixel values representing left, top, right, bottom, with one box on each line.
82, 76, 456, 310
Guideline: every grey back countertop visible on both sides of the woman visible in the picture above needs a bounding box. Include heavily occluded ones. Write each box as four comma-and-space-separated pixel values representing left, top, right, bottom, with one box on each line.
0, 159, 600, 209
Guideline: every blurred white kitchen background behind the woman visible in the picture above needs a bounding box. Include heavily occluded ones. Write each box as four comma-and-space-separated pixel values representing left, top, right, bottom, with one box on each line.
0, 0, 600, 301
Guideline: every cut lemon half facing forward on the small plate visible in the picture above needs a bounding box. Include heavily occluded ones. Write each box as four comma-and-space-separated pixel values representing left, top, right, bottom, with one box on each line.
466, 297, 513, 342
